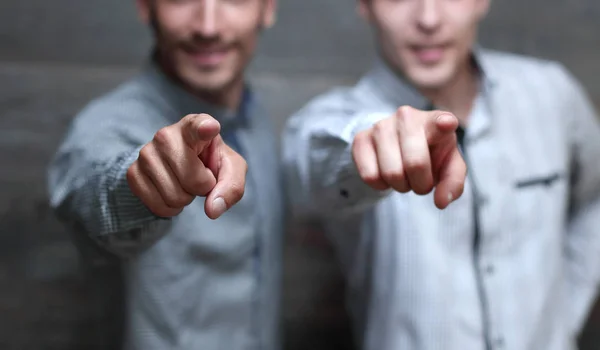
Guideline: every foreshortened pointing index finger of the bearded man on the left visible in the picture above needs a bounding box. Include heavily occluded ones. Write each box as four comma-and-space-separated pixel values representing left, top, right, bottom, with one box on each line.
179, 113, 221, 155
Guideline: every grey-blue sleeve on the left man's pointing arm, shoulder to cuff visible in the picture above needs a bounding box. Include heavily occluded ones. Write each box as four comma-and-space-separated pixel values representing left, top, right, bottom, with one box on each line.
48, 98, 170, 257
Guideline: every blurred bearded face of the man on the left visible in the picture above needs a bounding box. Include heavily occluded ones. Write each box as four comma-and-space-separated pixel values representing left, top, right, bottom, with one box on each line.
137, 0, 276, 102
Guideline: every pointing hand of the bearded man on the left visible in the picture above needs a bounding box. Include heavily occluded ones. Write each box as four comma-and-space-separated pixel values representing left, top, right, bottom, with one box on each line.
127, 114, 248, 219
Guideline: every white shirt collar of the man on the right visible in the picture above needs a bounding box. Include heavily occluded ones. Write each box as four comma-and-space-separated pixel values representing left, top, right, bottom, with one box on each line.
369, 45, 497, 109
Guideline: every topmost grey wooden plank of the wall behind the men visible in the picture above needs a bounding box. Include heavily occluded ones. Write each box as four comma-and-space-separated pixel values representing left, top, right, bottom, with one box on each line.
0, 0, 600, 85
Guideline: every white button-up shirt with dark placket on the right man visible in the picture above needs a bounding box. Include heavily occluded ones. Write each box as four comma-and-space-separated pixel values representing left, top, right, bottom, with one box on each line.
284, 50, 600, 350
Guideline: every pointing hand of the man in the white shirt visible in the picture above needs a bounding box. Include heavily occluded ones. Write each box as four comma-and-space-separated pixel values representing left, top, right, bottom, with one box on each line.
352, 106, 467, 209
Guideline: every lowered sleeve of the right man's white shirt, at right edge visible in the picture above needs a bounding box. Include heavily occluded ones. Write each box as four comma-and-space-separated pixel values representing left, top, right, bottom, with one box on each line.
559, 66, 600, 333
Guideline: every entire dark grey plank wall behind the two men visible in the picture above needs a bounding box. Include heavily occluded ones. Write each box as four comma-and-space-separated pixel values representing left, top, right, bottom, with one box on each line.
0, 0, 600, 350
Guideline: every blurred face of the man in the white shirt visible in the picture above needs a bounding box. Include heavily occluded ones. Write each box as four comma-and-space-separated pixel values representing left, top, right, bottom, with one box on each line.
359, 0, 489, 89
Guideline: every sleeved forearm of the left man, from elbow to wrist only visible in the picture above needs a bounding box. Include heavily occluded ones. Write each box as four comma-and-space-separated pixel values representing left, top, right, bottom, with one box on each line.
49, 148, 170, 256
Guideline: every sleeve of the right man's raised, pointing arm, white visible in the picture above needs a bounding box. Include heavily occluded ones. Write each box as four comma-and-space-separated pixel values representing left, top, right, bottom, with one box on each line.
283, 91, 391, 217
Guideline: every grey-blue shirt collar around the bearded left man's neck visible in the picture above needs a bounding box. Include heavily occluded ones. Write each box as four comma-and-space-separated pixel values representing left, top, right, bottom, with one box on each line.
143, 53, 255, 128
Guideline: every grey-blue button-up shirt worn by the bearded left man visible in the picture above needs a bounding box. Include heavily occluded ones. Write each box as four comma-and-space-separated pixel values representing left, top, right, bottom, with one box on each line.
49, 60, 283, 350
